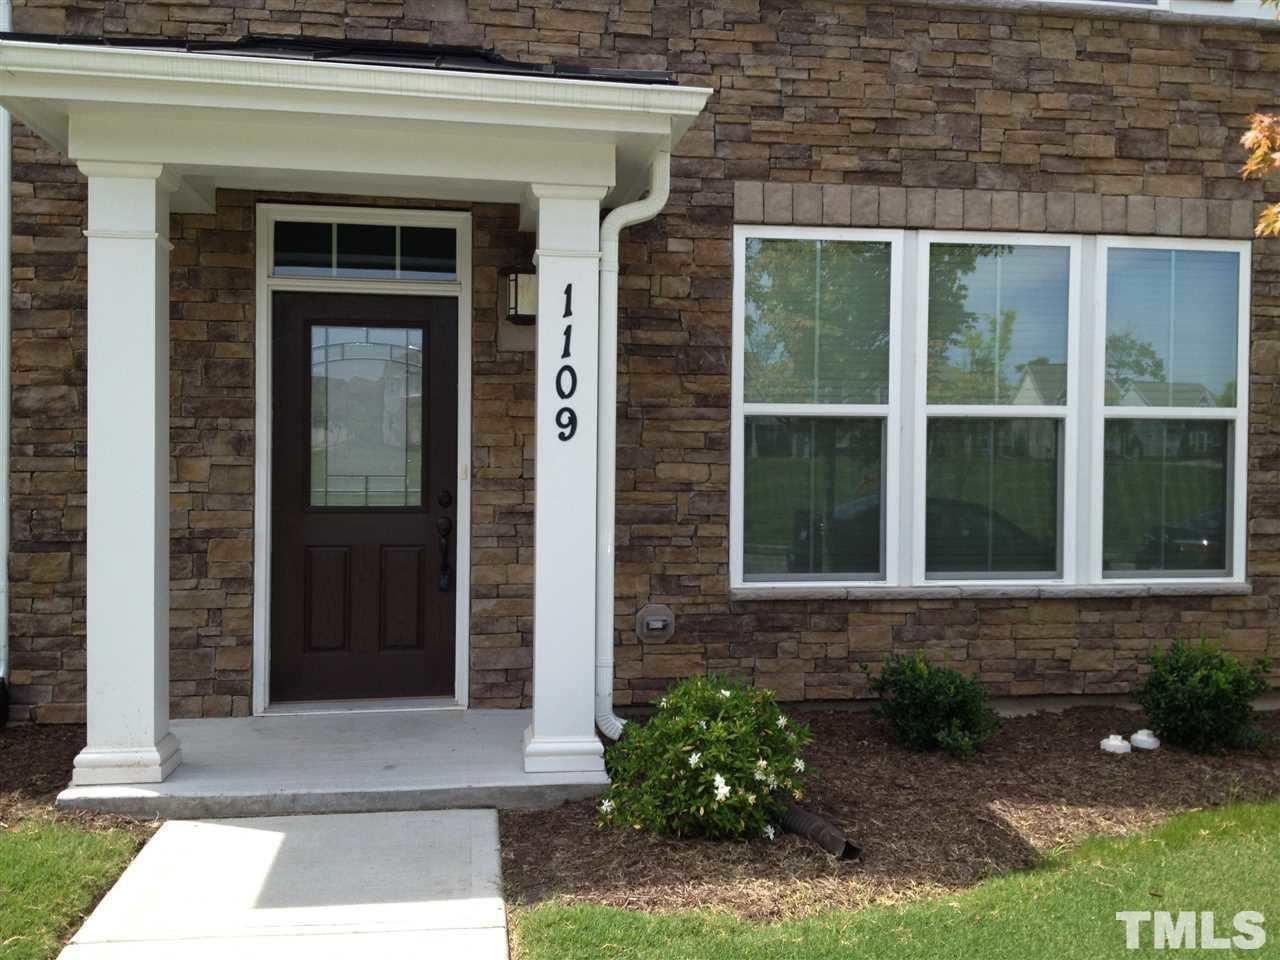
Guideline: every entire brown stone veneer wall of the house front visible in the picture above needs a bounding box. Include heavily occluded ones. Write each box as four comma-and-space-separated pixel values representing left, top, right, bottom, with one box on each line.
10, 0, 1280, 721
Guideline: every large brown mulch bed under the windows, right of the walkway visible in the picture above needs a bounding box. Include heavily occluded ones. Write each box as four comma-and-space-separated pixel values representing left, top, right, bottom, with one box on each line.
500, 707, 1280, 920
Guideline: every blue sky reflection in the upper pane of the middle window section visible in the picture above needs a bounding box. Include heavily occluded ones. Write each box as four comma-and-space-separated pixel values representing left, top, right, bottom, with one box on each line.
936, 244, 1070, 386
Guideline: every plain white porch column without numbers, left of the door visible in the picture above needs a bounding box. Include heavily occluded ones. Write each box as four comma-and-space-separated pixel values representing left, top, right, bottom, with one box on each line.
72, 161, 180, 786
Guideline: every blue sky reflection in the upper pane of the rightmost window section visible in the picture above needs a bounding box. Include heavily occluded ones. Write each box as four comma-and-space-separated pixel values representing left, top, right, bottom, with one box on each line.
1107, 248, 1239, 404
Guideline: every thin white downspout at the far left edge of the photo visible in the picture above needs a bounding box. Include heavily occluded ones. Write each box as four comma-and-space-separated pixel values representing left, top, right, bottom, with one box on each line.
0, 0, 13, 727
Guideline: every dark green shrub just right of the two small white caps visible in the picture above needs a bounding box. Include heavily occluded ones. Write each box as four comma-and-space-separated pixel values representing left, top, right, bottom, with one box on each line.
1133, 640, 1268, 753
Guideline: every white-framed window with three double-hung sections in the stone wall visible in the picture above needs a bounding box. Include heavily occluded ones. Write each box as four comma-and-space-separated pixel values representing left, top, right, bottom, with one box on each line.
731, 228, 1248, 585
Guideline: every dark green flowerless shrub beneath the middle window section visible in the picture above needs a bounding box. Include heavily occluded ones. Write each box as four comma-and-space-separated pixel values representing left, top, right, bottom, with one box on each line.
863, 650, 1000, 756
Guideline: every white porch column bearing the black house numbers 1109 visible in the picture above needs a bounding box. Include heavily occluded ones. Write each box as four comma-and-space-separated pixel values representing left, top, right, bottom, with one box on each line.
525, 184, 605, 772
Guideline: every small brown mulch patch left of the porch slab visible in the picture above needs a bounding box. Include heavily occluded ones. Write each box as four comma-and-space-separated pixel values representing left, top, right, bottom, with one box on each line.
0, 724, 159, 840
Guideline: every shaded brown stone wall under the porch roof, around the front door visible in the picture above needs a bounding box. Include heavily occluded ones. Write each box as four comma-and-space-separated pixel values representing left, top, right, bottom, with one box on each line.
10, 179, 534, 722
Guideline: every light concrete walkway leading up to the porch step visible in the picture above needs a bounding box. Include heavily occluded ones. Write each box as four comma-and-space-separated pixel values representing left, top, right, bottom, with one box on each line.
61, 810, 507, 960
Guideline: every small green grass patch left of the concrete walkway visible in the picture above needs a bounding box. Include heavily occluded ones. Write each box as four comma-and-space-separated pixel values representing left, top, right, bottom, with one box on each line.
0, 820, 140, 960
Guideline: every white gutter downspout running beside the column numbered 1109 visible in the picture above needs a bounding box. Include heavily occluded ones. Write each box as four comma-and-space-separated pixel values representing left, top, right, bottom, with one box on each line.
595, 150, 671, 740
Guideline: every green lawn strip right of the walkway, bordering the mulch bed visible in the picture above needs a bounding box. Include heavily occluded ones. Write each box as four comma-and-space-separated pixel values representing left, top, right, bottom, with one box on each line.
513, 803, 1280, 960
